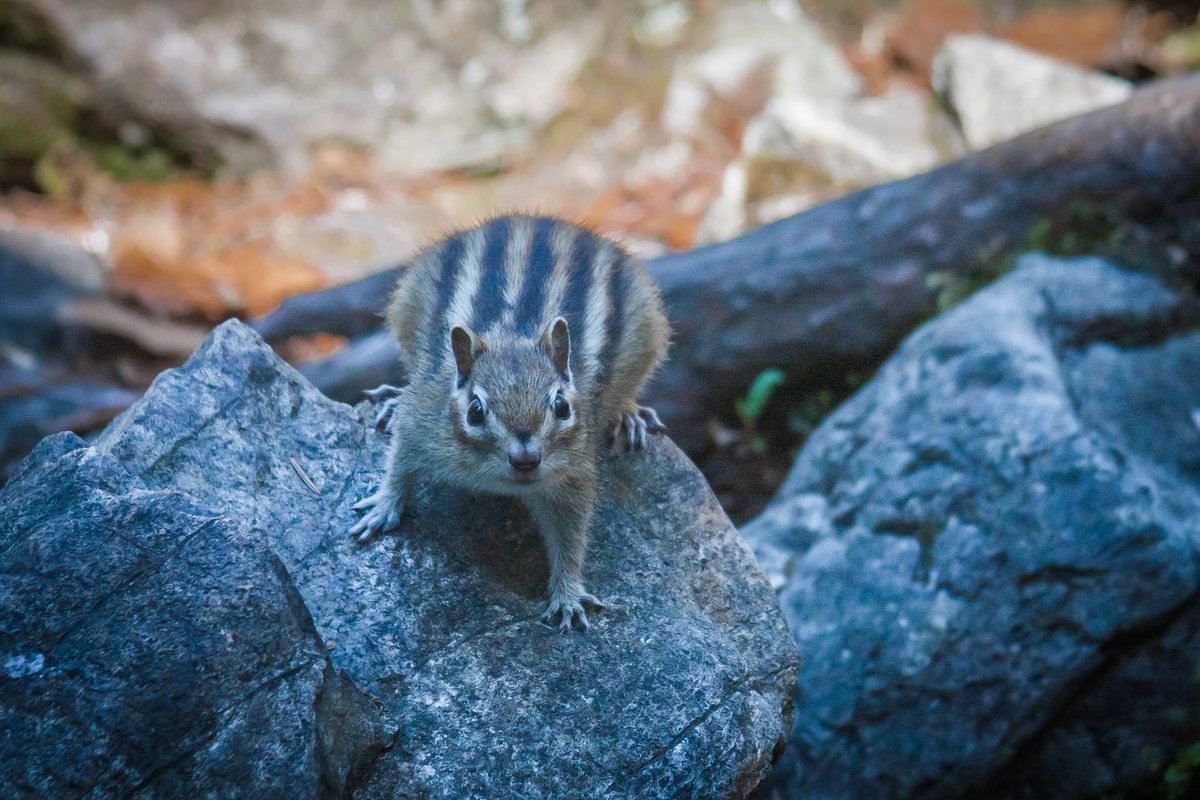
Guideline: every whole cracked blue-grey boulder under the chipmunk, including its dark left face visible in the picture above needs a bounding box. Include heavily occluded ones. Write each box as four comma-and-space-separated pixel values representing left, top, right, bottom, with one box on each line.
7, 323, 798, 798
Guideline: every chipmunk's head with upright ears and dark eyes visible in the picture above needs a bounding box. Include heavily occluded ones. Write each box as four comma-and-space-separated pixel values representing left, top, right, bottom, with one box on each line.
450, 318, 587, 494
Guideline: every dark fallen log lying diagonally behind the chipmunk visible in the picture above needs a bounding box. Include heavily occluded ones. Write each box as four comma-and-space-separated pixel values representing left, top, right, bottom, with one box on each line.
257, 74, 1200, 451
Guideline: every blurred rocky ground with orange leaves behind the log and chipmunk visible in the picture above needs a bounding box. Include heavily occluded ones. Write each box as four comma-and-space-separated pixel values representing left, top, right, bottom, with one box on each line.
0, 0, 1200, 513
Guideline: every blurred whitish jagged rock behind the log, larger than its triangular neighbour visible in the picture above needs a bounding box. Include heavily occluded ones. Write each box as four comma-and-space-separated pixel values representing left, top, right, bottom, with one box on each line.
681, 2, 955, 243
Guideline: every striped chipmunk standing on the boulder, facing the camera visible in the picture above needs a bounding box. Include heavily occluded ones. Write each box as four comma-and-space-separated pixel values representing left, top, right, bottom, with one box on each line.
350, 215, 670, 632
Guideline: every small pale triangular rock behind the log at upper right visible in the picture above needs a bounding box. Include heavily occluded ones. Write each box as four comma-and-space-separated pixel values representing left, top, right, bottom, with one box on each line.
932, 34, 1133, 149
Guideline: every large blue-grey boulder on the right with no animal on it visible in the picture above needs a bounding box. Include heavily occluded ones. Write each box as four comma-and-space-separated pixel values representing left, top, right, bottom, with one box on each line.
743, 255, 1200, 799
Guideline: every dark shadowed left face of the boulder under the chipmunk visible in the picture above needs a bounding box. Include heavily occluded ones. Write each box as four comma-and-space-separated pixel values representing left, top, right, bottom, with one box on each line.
0, 433, 384, 798
